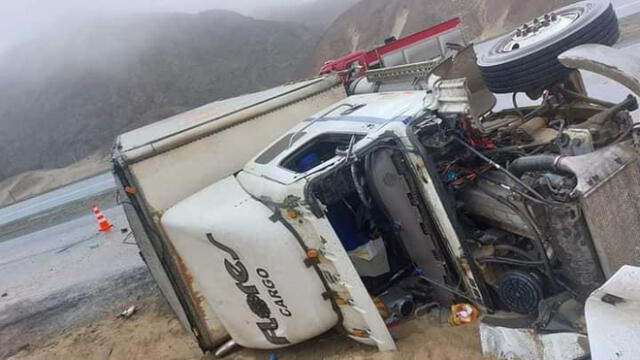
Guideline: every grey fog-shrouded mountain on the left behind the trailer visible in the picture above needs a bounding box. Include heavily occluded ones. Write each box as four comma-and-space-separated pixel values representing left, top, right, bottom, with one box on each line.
0, 11, 317, 180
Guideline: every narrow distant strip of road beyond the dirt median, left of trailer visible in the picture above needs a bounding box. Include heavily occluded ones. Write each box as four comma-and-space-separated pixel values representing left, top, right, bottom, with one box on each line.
0, 173, 116, 226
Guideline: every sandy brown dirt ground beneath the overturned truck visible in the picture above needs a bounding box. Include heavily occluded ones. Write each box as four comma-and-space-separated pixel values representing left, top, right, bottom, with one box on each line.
9, 297, 489, 360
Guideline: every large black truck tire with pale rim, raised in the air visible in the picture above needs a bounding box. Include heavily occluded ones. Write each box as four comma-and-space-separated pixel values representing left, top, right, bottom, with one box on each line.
475, 0, 620, 93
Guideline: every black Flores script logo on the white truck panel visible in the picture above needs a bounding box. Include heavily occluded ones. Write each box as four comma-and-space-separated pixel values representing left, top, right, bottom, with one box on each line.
207, 234, 291, 345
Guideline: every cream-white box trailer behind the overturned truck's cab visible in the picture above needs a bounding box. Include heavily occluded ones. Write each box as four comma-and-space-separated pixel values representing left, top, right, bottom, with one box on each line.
114, 76, 346, 350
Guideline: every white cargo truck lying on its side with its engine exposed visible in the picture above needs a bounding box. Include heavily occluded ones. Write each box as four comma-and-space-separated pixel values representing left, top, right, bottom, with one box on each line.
114, 1, 640, 358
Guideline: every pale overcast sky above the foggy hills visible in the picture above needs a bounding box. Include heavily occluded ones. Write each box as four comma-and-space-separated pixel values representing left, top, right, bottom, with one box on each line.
0, 0, 310, 50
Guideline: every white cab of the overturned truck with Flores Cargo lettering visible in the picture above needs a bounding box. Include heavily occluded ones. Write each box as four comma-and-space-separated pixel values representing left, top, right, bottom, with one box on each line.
162, 91, 478, 350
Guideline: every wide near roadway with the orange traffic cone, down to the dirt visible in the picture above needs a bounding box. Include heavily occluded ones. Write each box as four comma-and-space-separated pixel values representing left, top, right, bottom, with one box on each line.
0, 206, 149, 358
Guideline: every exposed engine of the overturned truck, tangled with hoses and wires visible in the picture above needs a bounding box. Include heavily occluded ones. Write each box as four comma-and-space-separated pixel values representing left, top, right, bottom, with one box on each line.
417, 91, 638, 304
